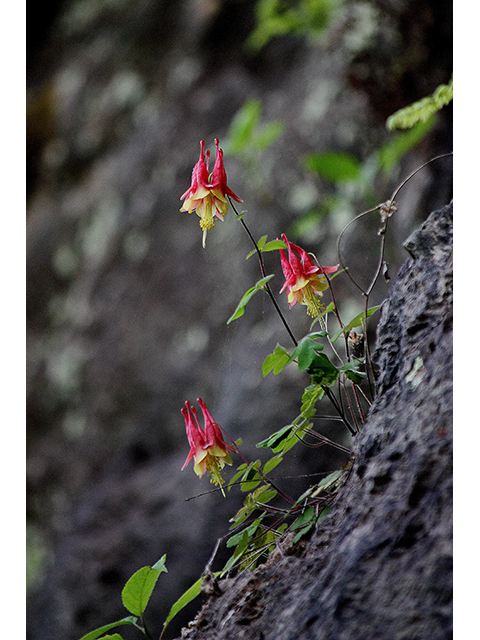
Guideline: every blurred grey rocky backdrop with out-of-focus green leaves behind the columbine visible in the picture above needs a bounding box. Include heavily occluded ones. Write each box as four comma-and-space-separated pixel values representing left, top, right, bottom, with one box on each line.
27, 0, 452, 640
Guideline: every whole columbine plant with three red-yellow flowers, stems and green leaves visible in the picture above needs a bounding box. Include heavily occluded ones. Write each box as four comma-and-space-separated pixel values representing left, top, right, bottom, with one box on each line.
81, 121, 452, 640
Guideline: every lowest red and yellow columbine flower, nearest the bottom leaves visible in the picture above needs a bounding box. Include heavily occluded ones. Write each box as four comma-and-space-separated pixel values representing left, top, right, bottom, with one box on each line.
181, 398, 234, 495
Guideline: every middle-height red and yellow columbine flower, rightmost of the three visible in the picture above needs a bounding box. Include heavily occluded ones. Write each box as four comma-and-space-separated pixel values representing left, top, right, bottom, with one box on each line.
280, 233, 339, 318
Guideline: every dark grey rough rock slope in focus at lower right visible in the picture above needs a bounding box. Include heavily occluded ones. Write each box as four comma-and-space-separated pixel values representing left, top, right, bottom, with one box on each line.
174, 205, 453, 640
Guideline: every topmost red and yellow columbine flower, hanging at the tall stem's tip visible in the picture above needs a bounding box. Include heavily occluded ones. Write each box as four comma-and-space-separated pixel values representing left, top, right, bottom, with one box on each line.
180, 138, 243, 247
